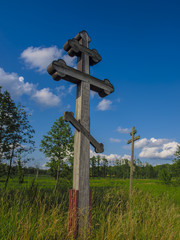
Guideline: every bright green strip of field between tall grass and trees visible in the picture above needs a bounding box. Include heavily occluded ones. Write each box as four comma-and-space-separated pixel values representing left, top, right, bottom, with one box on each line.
0, 175, 180, 206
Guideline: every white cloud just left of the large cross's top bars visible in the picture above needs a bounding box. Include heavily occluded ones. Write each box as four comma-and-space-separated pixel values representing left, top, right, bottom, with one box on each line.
20, 46, 75, 73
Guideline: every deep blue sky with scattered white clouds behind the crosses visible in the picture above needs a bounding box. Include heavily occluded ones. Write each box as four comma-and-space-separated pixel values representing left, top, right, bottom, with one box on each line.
0, 0, 180, 166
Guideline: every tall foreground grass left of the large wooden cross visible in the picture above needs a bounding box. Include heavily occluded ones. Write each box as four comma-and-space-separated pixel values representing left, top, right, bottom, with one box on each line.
0, 182, 68, 240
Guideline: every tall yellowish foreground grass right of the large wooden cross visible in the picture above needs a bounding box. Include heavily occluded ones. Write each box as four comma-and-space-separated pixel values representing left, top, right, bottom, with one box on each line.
92, 188, 180, 240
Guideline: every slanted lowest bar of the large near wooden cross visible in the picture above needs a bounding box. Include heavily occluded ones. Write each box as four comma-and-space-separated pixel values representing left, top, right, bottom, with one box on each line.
64, 112, 104, 153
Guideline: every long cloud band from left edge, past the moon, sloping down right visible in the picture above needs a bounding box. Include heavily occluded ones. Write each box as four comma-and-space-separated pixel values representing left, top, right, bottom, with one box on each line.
0, 68, 60, 107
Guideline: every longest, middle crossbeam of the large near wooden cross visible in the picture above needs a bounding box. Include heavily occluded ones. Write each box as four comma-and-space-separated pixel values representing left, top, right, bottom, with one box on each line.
47, 59, 114, 97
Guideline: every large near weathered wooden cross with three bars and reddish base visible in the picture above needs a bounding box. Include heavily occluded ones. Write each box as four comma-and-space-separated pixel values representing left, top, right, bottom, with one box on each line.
47, 31, 114, 239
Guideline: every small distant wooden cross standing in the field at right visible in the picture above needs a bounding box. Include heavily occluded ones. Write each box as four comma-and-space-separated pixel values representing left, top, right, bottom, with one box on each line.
127, 127, 140, 196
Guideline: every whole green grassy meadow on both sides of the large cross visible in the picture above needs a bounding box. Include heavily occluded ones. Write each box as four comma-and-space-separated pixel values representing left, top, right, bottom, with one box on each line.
0, 175, 180, 240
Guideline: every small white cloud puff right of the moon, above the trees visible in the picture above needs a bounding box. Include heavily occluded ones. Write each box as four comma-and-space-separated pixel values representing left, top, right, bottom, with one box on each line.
32, 88, 60, 107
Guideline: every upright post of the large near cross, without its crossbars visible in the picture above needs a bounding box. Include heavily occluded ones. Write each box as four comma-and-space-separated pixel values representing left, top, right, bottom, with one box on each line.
73, 31, 90, 239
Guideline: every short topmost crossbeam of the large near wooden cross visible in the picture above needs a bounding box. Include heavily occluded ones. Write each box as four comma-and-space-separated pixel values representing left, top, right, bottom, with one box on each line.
63, 38, 102, 66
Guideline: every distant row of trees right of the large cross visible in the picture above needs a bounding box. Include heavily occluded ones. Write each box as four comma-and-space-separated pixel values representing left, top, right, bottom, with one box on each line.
90, 156, 180, 182
